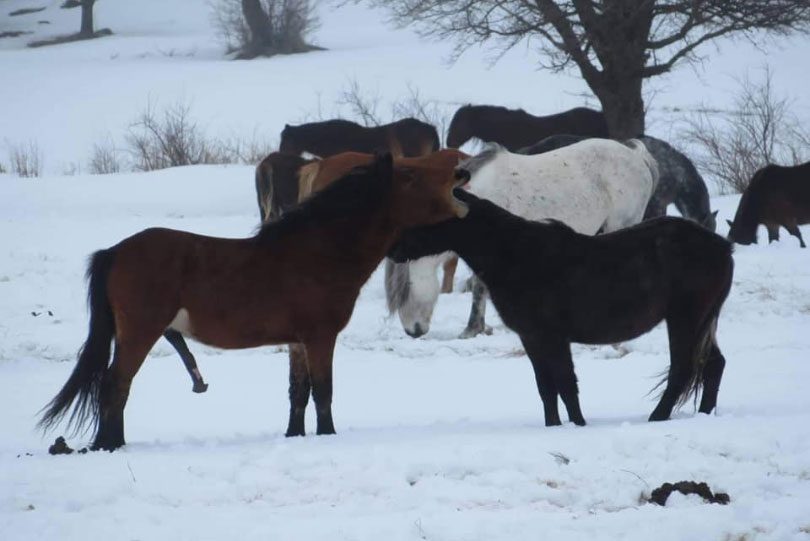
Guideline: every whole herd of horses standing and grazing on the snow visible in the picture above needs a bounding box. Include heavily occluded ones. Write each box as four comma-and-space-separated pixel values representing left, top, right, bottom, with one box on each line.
40, 105, 810, 450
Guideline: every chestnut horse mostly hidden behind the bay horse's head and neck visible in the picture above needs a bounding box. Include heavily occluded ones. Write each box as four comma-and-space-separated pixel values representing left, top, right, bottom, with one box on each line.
298, 149, 469, 293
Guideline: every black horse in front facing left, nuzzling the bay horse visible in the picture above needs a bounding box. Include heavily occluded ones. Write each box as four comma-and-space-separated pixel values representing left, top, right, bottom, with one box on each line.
389, 190, 734, 426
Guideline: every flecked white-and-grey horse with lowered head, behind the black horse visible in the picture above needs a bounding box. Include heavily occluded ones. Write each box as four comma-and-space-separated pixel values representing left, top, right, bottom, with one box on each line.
386, 139, 658, 338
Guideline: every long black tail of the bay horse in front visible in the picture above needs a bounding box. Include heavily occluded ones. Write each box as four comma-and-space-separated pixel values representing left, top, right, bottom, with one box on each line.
38, 248, 115, 433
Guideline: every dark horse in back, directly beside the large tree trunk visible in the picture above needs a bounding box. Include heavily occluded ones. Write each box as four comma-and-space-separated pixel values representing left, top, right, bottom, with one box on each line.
447, 105, 608, 152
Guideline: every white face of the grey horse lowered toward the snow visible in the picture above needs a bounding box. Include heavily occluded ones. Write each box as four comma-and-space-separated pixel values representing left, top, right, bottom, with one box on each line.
392, 254, 450, 336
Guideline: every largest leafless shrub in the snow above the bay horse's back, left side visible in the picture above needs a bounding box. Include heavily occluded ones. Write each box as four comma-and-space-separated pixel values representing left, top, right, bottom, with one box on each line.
126, 102, 225, 171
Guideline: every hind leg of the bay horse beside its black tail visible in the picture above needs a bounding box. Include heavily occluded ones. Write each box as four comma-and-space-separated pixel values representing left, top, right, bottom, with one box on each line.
91, 334, 160, 451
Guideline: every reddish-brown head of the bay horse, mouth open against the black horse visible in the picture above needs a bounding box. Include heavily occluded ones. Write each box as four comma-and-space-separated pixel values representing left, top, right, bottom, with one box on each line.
388, 155, 470, 228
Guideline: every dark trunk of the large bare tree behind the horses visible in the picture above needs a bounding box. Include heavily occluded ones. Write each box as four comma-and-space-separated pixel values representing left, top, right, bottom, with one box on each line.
593, 79, 644, 139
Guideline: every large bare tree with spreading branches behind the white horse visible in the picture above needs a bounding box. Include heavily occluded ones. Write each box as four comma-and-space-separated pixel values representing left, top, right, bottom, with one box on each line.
367, 0, 810, 138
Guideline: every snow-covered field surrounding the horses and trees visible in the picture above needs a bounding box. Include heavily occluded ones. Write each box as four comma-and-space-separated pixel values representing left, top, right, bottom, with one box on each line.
0, 0, 810, 541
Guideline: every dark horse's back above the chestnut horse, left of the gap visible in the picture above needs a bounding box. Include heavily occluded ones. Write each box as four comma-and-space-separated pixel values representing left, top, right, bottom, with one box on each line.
279, 118, 440, 158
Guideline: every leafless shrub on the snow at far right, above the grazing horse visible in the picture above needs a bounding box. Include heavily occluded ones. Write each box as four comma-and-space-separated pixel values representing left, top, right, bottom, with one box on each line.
685, 68, 810, 193
